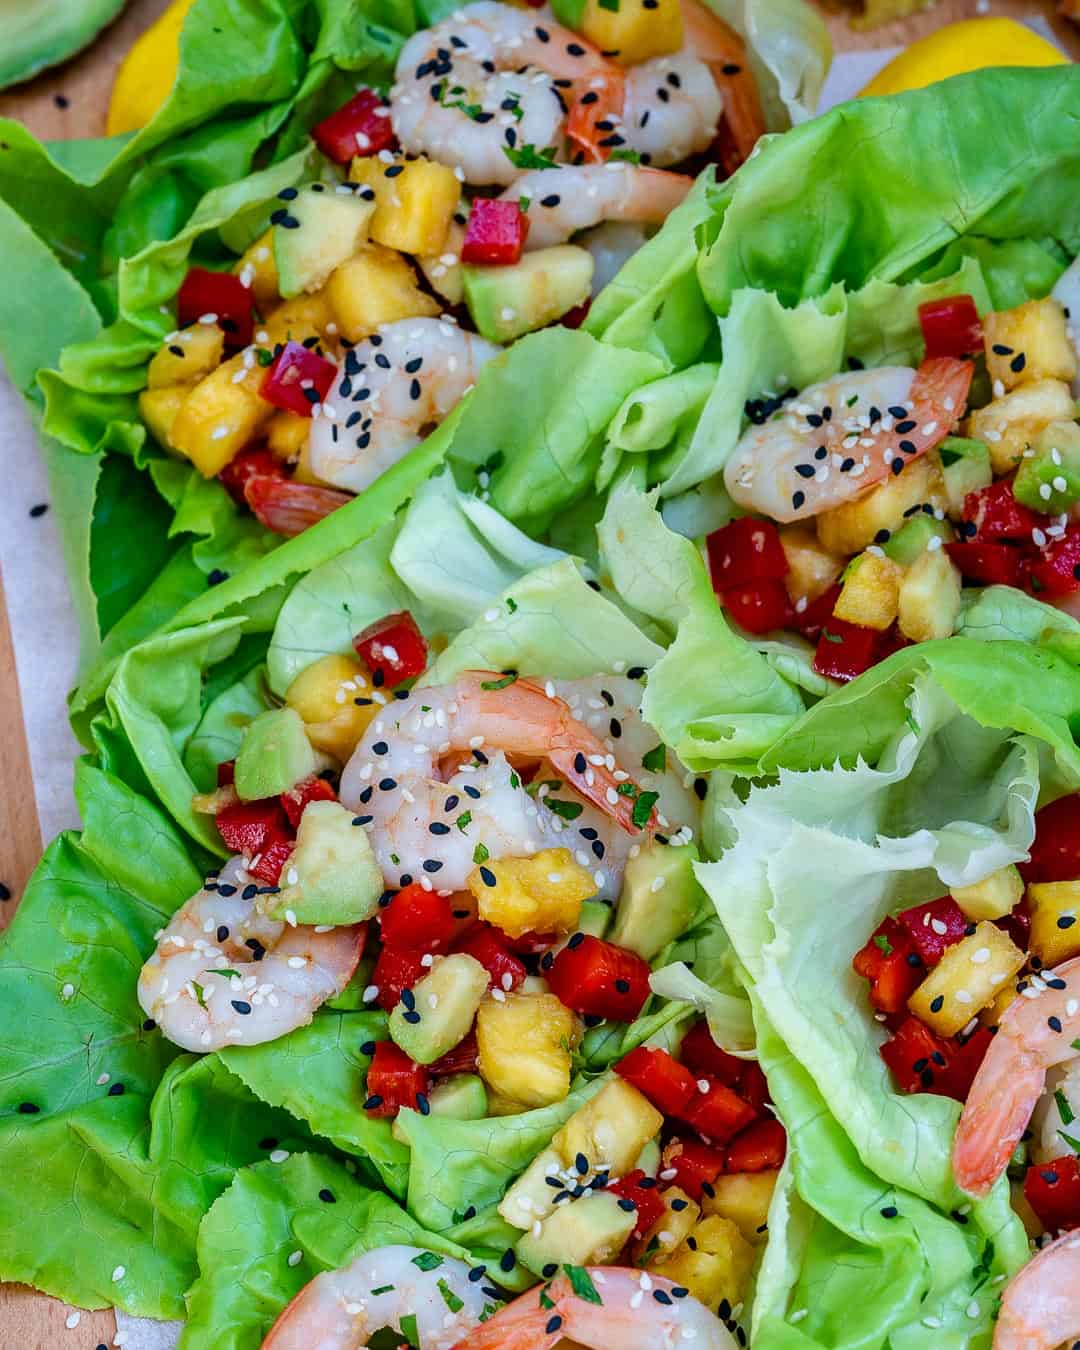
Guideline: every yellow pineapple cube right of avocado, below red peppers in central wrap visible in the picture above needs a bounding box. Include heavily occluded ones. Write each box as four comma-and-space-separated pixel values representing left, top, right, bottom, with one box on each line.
477, 991, 579, 1107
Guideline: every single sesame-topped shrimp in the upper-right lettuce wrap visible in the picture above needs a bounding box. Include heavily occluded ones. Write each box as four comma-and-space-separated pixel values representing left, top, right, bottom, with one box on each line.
724, 356, 973, 522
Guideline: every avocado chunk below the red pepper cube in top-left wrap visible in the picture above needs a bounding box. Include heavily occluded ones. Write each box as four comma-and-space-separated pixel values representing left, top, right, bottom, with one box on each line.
462, 244, 594, 343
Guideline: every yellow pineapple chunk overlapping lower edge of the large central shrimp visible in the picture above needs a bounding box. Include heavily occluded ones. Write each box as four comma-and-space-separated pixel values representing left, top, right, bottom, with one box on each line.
467, 848, 597, 937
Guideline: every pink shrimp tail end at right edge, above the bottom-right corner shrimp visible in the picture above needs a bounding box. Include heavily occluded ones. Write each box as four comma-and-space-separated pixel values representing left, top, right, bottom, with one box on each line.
953, 957, 1080, 1196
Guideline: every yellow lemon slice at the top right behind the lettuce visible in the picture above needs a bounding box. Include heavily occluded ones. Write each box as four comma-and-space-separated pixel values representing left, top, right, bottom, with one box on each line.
861, 19, 1069, 95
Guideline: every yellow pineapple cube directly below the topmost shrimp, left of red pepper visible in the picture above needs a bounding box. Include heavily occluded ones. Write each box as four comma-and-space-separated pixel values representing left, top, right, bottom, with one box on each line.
348, 155, 462, 255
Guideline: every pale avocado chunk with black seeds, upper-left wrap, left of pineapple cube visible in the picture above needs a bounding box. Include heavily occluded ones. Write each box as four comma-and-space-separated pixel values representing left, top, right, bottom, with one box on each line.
274, 182, 375, 300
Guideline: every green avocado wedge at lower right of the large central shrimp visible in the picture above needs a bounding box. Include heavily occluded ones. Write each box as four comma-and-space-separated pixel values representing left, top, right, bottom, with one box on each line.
609, 840, 702, 961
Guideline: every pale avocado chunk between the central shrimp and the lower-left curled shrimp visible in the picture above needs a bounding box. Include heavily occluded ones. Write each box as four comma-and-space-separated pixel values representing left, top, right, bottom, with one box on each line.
266, 802, 382, 925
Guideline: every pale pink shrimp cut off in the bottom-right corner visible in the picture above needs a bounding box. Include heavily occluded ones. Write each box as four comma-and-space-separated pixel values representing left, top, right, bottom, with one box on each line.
994, 1233, 1080, 1350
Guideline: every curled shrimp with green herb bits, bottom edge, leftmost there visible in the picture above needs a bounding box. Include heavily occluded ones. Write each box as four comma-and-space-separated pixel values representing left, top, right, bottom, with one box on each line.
262, 1246, 495, 1350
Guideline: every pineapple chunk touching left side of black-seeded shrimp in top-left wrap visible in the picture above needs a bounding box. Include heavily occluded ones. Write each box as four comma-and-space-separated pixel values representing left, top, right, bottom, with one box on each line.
170, 356, 274, 478
